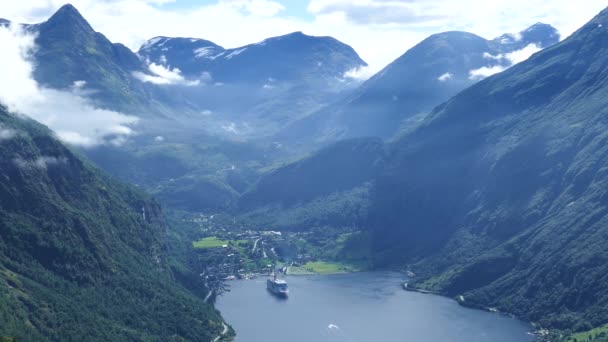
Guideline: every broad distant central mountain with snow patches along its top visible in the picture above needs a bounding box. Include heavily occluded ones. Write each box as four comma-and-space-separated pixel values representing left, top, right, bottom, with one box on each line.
138, 32, 367, 139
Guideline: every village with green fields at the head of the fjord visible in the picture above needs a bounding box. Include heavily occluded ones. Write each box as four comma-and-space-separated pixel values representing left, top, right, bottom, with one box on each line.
183, 213, 338, 295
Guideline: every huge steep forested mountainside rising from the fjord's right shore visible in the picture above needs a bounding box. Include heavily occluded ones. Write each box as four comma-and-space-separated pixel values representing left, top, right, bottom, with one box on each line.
369, 9, 608, 331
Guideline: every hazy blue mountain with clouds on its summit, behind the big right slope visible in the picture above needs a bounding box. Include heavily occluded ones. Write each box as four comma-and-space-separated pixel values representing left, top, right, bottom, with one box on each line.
278, 23, 559, 146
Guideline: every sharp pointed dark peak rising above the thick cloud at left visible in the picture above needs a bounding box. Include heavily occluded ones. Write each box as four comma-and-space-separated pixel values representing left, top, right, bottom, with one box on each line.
26, 5, 159, 114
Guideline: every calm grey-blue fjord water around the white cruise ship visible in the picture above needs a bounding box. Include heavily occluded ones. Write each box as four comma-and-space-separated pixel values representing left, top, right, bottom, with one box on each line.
217, 272, 533, 342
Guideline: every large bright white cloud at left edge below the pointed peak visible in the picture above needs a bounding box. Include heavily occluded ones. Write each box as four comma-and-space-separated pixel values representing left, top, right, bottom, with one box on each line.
0, 26, 137, 147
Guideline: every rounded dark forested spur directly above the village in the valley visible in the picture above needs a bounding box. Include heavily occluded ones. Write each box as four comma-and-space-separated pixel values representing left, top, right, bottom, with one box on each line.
239, 138, 385, 229
